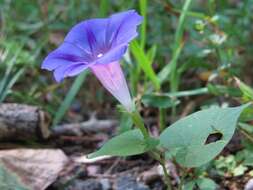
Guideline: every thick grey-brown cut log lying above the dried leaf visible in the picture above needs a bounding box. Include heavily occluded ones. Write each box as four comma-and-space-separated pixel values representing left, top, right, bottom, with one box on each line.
0, 103, 50, 141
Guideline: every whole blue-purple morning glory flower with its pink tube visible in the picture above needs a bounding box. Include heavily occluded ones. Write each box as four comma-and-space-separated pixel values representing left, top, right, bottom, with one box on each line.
42, 10, 142, 111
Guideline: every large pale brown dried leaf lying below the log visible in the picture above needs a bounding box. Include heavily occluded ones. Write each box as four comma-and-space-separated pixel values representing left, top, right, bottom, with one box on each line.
0, 149, 69, 190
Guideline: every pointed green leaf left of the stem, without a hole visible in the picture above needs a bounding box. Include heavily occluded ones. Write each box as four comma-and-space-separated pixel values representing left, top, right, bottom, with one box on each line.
89, 129, 159, 158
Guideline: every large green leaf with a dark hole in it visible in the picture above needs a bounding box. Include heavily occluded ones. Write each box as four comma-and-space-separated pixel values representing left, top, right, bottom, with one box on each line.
160, 104, 249, 167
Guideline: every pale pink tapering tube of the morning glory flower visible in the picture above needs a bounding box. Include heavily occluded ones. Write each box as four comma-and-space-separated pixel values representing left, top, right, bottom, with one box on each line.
90, 62, 134, 112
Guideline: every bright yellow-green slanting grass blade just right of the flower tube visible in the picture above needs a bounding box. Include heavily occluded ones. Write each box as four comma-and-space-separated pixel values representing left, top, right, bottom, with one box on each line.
130, 41, 160, 89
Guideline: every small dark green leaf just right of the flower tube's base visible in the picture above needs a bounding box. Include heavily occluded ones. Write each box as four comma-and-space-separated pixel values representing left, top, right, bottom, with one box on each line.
141, 94, 179, 108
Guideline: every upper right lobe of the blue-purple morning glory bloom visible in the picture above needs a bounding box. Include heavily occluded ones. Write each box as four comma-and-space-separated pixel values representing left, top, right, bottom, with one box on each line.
106, 10, 143, 45
